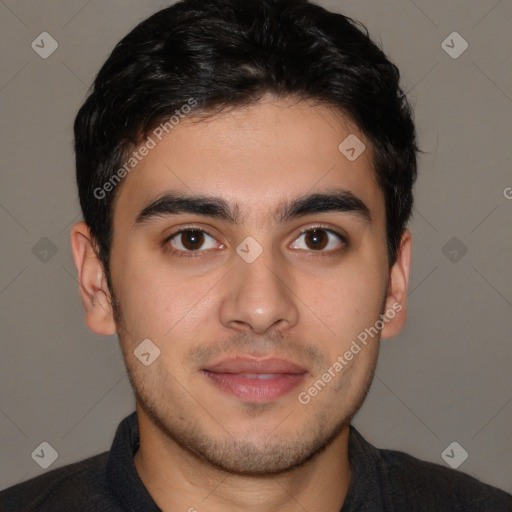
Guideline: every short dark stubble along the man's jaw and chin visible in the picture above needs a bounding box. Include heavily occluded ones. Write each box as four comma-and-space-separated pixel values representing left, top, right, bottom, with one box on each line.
112, 288, 384, 476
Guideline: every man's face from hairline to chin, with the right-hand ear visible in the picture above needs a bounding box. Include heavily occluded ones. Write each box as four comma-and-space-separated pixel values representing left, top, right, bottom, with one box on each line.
72, 99, 408, 474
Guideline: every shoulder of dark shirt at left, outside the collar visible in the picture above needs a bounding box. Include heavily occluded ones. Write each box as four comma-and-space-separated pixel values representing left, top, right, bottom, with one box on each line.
0, 452, 114, 512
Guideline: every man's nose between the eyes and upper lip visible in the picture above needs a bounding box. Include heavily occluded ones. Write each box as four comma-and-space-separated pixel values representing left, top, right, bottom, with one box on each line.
219, 245, 299, 334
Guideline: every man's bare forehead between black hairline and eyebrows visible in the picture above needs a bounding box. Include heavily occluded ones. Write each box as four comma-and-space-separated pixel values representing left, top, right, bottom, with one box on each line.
114, 99, 384, 225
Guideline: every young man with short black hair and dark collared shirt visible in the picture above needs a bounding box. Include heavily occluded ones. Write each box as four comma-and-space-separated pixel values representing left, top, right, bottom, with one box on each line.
0, 0, 512, 512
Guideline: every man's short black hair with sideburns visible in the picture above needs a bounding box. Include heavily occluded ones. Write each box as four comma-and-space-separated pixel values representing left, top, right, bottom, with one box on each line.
74, 0, 419, 286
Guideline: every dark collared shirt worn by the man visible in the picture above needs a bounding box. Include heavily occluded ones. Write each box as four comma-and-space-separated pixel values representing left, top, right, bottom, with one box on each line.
0, 412, 512, 512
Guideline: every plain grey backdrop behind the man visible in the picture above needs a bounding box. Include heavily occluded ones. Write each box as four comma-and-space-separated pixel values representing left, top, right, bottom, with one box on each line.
0, 0, 512, 492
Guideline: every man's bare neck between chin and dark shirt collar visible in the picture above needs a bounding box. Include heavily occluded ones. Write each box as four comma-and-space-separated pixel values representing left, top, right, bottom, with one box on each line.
134, 406, 351, 512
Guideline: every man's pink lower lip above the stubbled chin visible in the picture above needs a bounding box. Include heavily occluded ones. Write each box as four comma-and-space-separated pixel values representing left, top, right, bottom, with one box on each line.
203, 370, 306, 402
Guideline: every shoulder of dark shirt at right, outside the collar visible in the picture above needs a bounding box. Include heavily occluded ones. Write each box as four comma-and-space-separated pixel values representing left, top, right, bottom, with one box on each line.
378, 449, 512, 512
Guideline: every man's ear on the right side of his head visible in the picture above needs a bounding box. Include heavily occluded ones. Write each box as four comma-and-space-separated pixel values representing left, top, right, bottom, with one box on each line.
381, 229, 412, 339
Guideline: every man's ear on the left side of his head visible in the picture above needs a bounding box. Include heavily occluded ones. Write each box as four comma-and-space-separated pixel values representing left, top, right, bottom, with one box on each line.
71, 222, 116, 335
